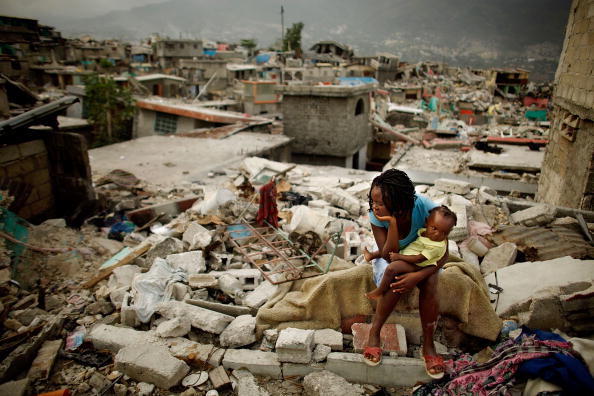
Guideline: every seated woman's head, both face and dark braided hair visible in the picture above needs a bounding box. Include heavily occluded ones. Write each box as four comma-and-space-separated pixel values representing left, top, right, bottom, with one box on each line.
369, 169, 416, 216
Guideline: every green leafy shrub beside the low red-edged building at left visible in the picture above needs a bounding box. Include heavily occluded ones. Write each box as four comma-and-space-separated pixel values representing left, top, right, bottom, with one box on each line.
85, 74, 134, 147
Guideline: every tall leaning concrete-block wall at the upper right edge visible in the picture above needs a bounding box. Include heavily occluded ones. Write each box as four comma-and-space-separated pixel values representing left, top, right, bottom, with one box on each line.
537, 0, 594, 210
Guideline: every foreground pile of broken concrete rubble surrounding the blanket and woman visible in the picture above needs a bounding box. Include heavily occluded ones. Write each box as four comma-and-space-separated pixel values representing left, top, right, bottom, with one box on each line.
0, 158, 594, 396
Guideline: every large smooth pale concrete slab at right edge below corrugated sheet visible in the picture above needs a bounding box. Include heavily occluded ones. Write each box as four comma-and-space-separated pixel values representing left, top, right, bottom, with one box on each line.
485, 256, 594, 317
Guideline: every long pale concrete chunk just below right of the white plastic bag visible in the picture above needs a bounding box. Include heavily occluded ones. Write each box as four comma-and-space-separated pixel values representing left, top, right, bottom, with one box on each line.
156, 301, 234, 334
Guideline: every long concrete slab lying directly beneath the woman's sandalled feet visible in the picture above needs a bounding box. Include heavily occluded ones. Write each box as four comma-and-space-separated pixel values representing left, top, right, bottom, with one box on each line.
326, 352, 431, 386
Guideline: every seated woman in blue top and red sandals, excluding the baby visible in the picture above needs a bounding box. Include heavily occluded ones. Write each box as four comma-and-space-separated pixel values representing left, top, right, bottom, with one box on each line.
363, 169, 448, 378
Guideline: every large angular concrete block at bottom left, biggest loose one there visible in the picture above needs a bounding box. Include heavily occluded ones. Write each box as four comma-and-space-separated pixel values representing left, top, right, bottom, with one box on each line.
114, 345, 190, 389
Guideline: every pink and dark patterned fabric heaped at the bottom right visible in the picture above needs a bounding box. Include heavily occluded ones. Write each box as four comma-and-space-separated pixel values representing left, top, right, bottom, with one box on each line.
413, 326, 592, 396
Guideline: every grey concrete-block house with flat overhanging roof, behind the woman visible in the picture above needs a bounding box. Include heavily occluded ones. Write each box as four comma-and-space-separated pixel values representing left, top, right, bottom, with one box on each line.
279, 84, 376, 169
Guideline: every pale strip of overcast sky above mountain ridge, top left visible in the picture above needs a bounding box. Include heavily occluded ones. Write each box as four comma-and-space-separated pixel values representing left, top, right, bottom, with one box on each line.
0, 0, 164, 23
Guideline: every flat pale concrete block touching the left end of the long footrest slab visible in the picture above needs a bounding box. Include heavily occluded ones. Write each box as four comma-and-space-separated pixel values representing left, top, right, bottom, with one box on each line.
223, 349, 282, 378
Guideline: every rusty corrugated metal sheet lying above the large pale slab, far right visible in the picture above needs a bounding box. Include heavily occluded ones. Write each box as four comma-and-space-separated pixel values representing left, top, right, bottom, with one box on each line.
491, 224, 594, 261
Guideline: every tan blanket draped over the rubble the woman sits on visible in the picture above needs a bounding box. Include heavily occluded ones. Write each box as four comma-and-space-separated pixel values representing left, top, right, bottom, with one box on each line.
256, 255, 501, 340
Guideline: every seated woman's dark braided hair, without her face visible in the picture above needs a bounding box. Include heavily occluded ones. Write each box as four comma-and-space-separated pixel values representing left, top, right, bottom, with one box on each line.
369, 169, 417, 215
